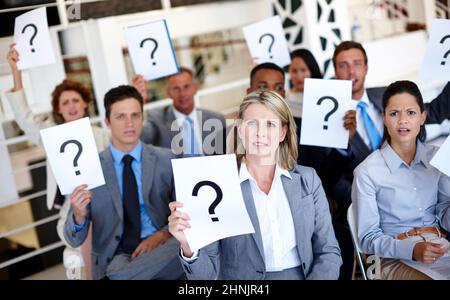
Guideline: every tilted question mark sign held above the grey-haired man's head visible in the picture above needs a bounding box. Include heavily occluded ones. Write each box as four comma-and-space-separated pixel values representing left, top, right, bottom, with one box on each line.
123, 20, 178, 80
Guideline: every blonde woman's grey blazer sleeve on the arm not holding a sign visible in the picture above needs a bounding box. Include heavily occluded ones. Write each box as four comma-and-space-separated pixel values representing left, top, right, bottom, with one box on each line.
304, 168, 342, 280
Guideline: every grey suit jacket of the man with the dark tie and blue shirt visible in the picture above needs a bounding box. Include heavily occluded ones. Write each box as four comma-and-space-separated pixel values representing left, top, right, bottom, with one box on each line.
64, 145, 175, 279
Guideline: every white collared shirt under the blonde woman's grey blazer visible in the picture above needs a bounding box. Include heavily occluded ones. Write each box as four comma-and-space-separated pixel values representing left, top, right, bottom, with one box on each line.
239, 163, 300, 272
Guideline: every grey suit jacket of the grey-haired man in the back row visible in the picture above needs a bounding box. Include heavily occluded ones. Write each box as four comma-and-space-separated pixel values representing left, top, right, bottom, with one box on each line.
141, 105, 225, 157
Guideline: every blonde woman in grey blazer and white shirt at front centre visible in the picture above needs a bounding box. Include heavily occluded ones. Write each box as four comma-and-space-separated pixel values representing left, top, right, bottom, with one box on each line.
169, 90, 342, 280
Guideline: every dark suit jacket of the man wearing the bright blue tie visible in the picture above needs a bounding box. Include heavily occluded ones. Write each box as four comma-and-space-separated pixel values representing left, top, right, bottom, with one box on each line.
322, 82, 450, 223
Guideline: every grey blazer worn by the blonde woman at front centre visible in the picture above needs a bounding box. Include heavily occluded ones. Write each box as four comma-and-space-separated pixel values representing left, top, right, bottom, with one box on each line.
180, 166, 342, 280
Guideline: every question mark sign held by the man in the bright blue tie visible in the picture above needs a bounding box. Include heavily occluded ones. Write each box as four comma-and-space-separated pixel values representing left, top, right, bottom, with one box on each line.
300, 78, 355, 149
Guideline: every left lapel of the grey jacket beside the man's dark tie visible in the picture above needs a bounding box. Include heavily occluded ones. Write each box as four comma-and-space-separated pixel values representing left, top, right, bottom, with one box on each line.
100, 148, 123, 220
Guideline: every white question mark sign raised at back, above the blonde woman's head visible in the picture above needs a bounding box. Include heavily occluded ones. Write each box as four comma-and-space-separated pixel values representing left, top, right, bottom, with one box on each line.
242, 16, 291, 67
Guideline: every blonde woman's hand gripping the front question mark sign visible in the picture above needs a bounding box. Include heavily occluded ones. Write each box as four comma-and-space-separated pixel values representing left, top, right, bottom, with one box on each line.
169, 201, 194, 257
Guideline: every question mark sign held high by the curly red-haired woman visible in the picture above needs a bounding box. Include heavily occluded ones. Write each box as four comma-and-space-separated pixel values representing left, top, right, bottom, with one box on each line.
14, 7, 55, 70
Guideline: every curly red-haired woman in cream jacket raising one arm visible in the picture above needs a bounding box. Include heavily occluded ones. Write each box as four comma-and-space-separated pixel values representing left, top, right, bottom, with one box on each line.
6, 44, 110, 279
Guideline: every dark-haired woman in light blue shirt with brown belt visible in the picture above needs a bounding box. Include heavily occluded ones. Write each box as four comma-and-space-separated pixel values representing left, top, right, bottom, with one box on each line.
352, 81, 450, 280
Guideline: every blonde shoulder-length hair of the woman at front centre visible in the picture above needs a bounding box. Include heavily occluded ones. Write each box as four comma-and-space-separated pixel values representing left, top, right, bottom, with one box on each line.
227, 90, 298, 170
